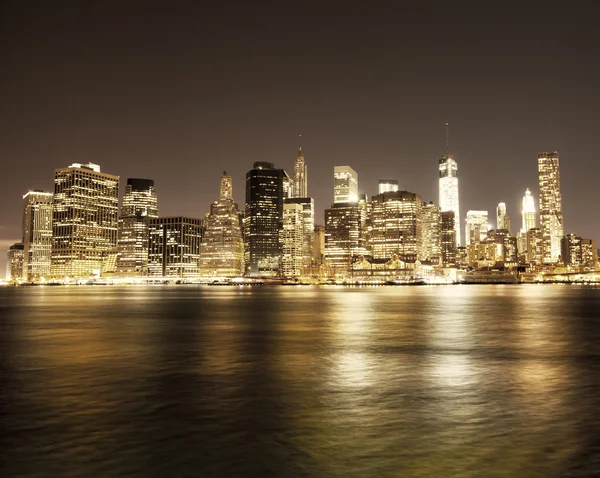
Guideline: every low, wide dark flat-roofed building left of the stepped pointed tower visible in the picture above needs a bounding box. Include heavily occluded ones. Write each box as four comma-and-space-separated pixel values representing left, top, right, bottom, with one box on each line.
148, 216, 204, 279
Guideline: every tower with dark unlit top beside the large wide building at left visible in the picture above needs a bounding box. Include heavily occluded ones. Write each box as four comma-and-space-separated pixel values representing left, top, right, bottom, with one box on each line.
117, 178, 158, 276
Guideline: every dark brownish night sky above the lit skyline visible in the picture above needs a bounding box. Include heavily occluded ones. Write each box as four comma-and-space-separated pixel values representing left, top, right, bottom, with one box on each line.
0, 1, 600, 272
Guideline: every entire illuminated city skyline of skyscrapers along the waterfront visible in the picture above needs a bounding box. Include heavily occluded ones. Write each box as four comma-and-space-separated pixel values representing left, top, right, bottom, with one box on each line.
7, 148, 598, 282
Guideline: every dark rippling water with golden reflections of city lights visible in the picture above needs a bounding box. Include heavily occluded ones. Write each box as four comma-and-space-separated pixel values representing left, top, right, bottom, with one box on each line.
0, 285, 600, 477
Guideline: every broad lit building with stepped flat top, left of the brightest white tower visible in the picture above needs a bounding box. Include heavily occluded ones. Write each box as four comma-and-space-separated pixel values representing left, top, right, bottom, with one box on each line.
370, 191, 423, 262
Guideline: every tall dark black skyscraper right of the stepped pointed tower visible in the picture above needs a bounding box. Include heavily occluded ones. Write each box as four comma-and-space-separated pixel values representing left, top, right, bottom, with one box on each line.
244, 162, 291, 276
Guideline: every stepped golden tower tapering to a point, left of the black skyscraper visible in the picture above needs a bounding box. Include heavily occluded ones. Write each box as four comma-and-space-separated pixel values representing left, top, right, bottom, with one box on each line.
200, 171, 244, 277
